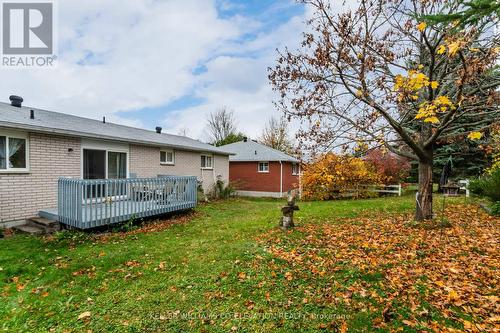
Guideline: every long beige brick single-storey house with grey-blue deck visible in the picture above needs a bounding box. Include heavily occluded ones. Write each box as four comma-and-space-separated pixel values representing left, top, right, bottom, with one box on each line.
0, 96, 230, 228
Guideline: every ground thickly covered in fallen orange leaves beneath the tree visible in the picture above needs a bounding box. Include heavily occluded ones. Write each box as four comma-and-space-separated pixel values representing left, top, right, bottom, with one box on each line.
262, 205, 500, 332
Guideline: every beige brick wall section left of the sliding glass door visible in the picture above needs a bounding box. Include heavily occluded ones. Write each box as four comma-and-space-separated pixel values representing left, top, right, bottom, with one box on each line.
0, 133, 81, 222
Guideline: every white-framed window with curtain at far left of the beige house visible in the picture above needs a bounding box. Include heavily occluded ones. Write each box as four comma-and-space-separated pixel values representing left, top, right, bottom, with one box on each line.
0, 135, 28, 172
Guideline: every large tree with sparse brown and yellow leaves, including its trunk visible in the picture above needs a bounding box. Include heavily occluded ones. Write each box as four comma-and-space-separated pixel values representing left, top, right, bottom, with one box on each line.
269, 0, 500, 221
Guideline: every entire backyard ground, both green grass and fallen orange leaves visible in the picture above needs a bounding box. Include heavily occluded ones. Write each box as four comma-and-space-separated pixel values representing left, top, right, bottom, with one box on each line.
0, 197, 499, 332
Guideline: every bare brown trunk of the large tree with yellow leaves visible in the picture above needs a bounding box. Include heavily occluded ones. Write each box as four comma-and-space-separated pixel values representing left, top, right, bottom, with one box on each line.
415, 157, 432, 221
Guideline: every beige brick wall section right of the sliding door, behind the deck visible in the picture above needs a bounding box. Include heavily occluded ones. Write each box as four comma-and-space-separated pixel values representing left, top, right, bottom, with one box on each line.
129, 145, 229, 191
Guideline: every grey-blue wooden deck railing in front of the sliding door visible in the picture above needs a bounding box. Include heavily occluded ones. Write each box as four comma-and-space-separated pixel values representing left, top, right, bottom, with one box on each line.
57, 176, 197, 229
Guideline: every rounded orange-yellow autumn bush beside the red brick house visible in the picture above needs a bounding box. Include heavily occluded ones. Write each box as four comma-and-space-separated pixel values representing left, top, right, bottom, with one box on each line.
302, 153, 381, 200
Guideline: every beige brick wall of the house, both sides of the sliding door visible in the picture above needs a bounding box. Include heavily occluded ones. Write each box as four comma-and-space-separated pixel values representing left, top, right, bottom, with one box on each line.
0, 133, 229, 222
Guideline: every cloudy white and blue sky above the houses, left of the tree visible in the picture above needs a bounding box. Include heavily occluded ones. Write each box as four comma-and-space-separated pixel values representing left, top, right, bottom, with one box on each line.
0, 0, 306, 140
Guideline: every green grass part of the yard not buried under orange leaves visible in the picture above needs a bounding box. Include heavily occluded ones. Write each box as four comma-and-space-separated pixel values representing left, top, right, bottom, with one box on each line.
0, 197, 492, 332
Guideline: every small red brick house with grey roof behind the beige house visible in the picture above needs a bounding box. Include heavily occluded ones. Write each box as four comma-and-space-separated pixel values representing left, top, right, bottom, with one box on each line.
221, 138, 300, 198
